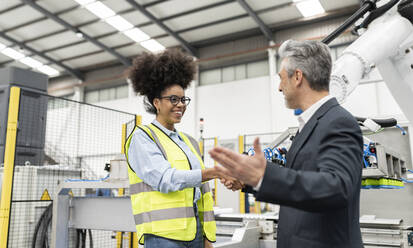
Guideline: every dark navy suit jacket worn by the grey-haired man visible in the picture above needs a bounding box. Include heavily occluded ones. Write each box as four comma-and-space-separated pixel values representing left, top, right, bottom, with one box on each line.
256, 98, 363, 248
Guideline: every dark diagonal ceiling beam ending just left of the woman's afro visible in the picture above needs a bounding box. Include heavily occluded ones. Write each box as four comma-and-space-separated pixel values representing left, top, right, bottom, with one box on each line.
21, 0, 131, 66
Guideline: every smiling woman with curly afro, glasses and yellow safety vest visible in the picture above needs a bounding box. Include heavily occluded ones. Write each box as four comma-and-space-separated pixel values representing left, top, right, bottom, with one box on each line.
125, 50, 232, 248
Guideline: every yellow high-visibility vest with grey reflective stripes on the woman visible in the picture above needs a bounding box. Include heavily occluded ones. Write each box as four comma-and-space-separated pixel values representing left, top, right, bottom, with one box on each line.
125, 124, 216, 245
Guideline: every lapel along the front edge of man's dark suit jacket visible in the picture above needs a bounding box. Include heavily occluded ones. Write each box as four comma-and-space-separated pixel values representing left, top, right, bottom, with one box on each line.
287, 98, 338, 168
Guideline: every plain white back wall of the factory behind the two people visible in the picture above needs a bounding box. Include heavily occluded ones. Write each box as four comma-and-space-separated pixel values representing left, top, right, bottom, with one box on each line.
91, 70, 407, 139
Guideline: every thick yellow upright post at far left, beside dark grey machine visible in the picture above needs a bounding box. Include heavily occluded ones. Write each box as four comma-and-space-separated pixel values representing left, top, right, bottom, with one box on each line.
0, 87, 20, 248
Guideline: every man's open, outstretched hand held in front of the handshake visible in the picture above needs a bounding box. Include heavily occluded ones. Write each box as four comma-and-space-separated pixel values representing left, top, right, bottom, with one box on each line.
209, 138, 267, 187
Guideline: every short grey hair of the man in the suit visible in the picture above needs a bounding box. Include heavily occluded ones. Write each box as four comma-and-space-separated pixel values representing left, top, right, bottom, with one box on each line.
278, 40, 332, 91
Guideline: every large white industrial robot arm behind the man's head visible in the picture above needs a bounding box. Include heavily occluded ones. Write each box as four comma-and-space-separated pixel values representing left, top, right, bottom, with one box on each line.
330, 0, 413, 123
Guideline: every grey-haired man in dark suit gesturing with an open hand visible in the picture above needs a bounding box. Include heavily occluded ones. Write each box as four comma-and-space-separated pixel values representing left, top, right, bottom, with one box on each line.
210, 40, 363, 248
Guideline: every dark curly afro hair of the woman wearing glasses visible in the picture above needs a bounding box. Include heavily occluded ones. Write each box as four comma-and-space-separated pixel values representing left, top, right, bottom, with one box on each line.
128, 49, 196, 114
